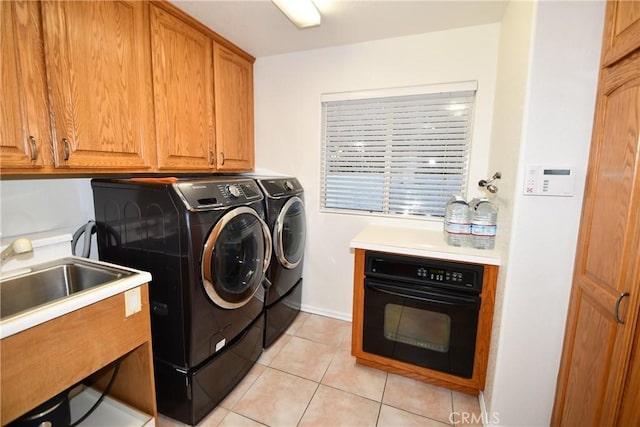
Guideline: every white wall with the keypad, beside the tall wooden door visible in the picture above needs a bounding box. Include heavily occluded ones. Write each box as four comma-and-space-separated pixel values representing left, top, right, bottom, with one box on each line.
485, 1, 604, 426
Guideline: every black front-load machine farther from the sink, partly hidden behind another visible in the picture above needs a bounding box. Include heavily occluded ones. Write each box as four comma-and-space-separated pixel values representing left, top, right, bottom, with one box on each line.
256, 177, 307, 348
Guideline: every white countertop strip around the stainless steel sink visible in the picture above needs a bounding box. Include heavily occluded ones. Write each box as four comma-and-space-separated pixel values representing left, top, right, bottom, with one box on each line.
0, 256, 151, 339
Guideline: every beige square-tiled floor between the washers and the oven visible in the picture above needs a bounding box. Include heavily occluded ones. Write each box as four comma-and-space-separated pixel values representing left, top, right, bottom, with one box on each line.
158, 312, 482, 427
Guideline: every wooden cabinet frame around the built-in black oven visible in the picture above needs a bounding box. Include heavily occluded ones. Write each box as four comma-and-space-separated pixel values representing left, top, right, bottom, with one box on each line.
351, 249, 498, 395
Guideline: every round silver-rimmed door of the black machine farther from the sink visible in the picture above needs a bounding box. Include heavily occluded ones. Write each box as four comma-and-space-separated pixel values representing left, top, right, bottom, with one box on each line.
273, 197, 307, 269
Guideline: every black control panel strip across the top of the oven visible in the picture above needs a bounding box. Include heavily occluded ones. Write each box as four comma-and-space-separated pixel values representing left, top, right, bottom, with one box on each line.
365, 252, 484, 292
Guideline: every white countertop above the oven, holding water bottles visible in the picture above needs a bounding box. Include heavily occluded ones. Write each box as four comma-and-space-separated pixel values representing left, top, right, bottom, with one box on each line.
350, 225, 500, 265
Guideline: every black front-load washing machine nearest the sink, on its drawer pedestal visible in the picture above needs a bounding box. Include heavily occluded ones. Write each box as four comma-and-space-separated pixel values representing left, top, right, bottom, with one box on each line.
91, 177, 271, 425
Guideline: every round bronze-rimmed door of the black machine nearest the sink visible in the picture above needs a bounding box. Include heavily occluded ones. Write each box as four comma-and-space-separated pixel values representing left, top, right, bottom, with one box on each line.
202, 206, 271, 309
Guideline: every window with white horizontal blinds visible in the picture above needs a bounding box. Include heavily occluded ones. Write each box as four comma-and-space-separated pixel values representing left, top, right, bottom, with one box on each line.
321, 82, 476, 218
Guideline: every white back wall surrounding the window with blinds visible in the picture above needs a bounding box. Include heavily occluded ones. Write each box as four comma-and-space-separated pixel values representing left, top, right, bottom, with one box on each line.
254, 24, 500, 319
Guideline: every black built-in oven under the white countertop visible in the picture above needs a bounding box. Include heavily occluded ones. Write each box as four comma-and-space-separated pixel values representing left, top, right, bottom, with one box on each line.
362, 251, 484, 378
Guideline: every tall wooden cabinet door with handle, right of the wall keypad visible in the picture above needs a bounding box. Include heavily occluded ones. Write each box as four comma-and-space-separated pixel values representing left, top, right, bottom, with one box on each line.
552, 51, 640, 426
